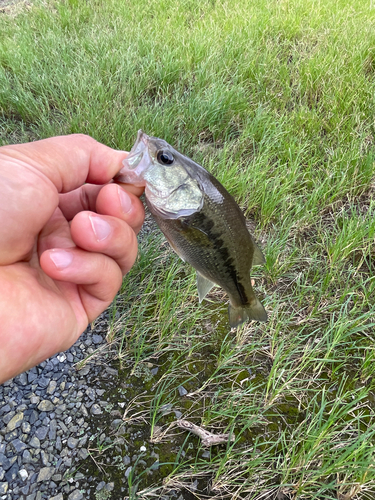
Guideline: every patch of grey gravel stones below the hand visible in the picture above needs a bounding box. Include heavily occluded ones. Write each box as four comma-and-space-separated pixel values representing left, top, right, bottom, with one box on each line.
0, 313, 125, 500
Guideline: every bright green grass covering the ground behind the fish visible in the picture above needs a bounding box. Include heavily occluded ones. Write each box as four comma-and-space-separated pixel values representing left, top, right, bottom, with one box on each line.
0, 0, 375, 500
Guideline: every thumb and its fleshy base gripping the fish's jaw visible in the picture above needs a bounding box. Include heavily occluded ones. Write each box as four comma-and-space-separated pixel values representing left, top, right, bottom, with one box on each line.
0, 134, 126, 265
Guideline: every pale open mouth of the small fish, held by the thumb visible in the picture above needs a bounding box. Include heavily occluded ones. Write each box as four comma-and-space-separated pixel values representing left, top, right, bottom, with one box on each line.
115, 130, 152, 186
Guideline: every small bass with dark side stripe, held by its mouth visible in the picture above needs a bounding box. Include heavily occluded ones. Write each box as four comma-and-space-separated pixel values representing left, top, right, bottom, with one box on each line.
114, 130, 267, 328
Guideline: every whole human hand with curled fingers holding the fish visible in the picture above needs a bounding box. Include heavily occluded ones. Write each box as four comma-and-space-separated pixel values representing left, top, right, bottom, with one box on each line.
0, 135, 144, 383
